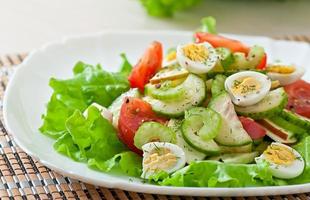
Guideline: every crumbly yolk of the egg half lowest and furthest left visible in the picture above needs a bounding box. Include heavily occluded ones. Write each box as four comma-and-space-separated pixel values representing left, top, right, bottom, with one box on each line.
143, 148, 177, 172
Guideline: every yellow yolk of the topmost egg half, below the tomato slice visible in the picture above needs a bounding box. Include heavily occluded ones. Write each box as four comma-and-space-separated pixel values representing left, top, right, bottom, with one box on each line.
183, 44, 209, 62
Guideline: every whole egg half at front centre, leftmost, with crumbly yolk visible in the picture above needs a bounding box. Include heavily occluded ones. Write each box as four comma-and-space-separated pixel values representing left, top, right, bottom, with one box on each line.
141, 142, 185, 179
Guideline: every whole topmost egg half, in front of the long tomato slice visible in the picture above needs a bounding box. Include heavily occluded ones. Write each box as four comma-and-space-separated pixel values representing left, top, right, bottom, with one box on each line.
176, 42, 218, 74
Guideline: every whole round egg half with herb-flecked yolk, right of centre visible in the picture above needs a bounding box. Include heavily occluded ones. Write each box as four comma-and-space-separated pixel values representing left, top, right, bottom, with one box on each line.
225, 71, 271, 106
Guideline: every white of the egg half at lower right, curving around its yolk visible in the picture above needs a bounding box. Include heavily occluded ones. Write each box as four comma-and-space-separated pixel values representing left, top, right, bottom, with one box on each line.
255, 142, 305, 179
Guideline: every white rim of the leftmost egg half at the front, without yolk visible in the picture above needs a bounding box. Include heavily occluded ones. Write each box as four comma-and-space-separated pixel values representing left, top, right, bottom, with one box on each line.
141, 142, 186, 179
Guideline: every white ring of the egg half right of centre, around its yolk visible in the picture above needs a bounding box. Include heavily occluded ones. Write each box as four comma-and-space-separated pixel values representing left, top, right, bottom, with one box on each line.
225, 71, 271, 106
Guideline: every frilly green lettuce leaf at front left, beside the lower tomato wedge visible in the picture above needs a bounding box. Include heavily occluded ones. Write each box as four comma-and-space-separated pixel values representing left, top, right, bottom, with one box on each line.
66, 106, 126, 160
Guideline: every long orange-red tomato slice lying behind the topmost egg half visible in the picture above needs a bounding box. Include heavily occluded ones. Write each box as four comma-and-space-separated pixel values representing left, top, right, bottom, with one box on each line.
194, 32, 250, 54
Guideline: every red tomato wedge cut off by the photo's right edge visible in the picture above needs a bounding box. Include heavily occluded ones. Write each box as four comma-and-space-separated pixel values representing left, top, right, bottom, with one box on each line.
284, 80, 310, 118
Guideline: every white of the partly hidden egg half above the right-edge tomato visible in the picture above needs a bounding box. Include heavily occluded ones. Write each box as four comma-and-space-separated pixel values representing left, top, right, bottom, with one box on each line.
267, 67, 305, 86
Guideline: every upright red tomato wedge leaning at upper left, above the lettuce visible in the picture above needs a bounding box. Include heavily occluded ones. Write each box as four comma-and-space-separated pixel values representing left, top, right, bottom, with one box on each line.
128, 41, 163, 92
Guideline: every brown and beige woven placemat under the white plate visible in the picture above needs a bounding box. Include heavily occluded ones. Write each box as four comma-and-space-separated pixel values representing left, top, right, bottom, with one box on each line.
0, 36, 310, 200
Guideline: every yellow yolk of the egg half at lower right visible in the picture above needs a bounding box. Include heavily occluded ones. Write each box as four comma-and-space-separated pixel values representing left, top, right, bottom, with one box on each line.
264, 145, 296, 165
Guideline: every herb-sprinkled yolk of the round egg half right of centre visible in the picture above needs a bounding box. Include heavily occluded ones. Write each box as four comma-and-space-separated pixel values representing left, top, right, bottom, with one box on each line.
232, 77, 261, 95
